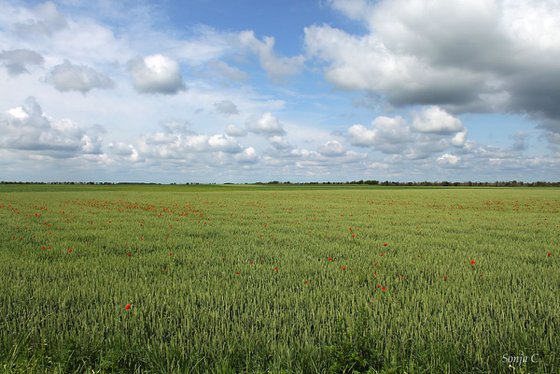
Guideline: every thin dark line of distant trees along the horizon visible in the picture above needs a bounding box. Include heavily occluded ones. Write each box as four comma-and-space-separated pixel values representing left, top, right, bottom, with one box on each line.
0, 179, 560, 187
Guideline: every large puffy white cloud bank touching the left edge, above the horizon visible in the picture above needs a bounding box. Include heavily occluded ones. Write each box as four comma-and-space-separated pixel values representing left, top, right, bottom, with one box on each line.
0, 97, 102, 158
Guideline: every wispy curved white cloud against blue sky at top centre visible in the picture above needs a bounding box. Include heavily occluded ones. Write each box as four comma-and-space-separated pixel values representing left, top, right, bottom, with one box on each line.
239, 31, 305, 80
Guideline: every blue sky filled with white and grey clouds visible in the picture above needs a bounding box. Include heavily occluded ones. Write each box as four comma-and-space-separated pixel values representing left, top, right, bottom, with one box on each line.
0, 0, 560, 183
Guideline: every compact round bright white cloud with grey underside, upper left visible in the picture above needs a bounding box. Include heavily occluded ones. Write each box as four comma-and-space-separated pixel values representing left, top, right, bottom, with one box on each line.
129, 54, 186, 95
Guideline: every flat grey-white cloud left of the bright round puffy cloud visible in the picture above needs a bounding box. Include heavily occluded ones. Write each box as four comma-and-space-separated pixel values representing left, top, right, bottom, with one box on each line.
47, 61, 115, 94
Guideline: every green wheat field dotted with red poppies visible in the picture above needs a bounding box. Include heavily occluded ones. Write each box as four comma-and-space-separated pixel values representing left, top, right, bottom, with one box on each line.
0, 185, 560, 373
